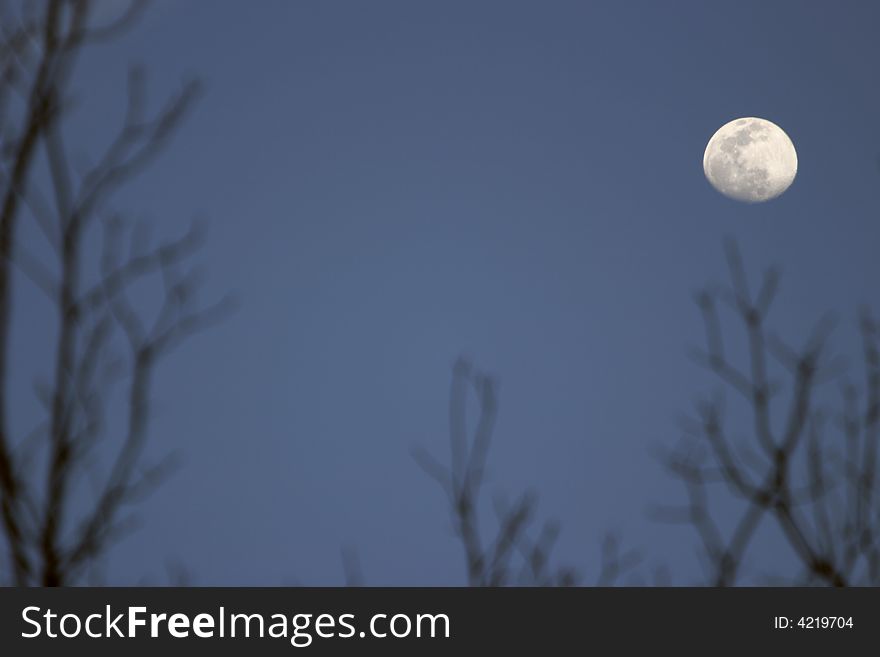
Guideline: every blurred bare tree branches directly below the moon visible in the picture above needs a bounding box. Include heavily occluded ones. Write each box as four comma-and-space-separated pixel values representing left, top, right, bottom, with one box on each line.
657, 242, 880, 586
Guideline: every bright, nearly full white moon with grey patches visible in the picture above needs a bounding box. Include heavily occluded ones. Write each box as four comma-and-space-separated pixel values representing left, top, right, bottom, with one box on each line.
703, 117, 797, 203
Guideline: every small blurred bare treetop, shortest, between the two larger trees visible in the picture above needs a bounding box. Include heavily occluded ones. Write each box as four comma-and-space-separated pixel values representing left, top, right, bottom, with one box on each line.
414, 359, 640, 586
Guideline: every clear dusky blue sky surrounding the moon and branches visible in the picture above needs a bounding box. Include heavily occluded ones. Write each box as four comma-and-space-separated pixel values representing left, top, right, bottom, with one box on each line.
17, 0, 880, 585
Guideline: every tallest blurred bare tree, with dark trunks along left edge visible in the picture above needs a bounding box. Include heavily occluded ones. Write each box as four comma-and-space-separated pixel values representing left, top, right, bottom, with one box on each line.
0, 0, 227, 585
